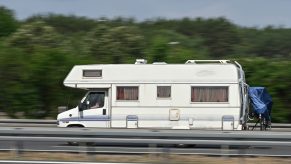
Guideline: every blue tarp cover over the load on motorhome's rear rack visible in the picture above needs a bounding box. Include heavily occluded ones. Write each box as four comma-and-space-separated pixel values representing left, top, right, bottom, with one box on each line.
249, 87, 273, 121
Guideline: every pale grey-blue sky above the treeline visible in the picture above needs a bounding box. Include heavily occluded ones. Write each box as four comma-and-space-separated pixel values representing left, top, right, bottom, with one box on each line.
0, 0, 291, 28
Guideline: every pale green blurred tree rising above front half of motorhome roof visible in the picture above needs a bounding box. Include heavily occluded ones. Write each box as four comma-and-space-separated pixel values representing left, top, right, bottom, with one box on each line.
86, 25, 144, 63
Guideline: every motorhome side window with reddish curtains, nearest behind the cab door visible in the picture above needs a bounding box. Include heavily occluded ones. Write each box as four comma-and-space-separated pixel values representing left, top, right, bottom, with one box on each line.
116, 87, 138, 100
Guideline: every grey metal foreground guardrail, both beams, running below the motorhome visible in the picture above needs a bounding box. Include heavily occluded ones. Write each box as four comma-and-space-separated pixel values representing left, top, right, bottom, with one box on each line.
0, 128, 291, 146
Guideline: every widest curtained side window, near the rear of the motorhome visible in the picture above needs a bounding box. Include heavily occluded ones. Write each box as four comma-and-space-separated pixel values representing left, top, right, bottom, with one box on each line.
191, 86, 228, 102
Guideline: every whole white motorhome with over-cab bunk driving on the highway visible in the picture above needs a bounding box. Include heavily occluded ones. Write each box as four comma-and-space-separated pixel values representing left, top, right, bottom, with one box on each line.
57, 59, 248, 130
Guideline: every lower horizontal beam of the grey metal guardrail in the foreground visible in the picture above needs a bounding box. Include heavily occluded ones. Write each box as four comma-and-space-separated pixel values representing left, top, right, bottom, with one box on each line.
0, 136, 291, 146
